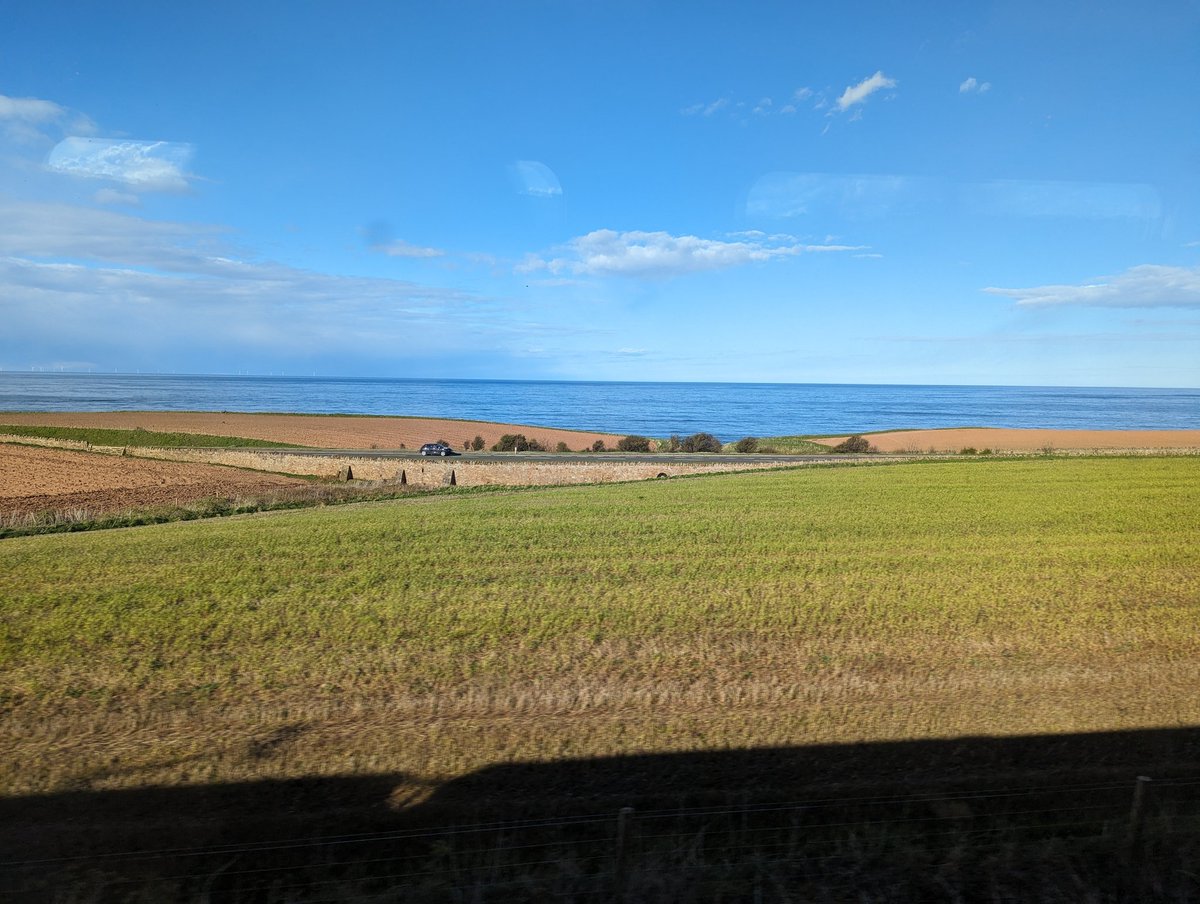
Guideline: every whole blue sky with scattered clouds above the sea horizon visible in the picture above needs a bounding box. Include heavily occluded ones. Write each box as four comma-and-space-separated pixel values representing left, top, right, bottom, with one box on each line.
0, 0, 1200, 387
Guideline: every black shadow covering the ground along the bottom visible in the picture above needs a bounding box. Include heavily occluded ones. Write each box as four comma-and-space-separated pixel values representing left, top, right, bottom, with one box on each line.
0, 728, 1200, 902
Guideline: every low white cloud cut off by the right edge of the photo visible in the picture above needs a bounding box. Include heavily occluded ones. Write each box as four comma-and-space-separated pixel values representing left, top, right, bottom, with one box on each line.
984, 264, 1200, 307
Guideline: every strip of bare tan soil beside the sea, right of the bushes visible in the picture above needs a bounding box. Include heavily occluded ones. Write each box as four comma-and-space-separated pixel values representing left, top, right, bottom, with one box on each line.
821, 427, 1200, 453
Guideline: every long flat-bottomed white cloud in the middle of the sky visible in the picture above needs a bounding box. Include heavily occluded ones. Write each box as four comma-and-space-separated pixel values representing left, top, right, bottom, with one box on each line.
517, 229, 863, 277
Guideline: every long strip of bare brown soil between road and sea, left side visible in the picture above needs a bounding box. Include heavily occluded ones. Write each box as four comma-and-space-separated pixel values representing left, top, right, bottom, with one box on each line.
0, 412, 622, 451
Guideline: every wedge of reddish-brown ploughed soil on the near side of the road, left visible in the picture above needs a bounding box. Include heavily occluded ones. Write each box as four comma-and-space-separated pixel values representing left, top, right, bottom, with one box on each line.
0, 444, 306, 516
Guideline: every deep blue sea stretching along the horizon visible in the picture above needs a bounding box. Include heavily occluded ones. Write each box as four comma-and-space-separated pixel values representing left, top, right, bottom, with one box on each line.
0, 372, 1200, 441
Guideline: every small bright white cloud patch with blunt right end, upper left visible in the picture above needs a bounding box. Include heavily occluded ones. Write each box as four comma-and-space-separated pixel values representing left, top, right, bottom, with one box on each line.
47, 137, 192, 191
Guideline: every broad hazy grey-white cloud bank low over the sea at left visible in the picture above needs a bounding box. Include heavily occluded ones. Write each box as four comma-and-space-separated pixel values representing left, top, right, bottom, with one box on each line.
0, 202, 533, 360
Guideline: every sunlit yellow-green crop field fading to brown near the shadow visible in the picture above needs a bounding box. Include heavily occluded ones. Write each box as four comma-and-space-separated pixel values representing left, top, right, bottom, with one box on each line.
0, 457, 1200, 794
